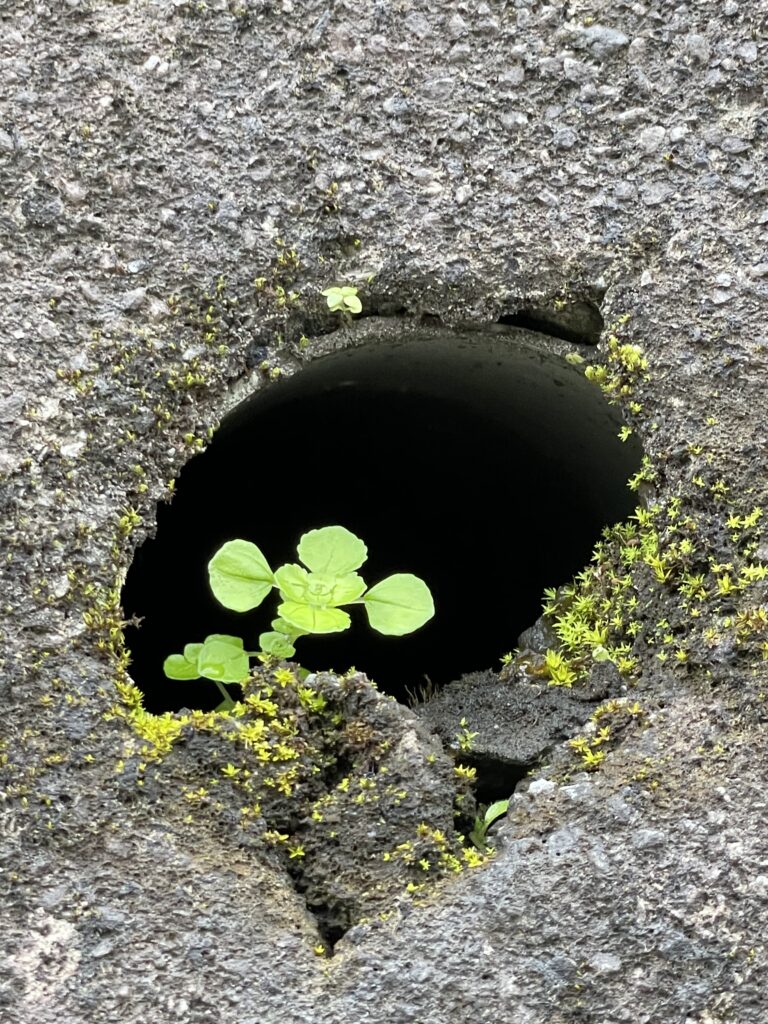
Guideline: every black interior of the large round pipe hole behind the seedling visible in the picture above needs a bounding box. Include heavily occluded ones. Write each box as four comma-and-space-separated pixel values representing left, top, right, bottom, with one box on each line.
123, 330, 641, 712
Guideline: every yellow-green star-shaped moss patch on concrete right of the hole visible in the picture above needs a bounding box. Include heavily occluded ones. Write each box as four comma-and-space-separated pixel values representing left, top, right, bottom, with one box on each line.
506, 477, 768, 686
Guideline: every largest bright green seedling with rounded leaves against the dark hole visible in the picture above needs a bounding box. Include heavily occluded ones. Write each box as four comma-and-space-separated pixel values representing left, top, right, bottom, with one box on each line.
163, 526, 434, 706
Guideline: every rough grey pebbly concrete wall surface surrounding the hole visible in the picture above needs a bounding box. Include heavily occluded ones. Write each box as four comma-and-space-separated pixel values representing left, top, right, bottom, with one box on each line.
0, 0, 768, 1024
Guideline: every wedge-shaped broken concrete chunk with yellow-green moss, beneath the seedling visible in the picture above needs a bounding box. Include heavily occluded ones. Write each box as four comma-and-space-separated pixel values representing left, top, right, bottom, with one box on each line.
106, 664, 487, 936
